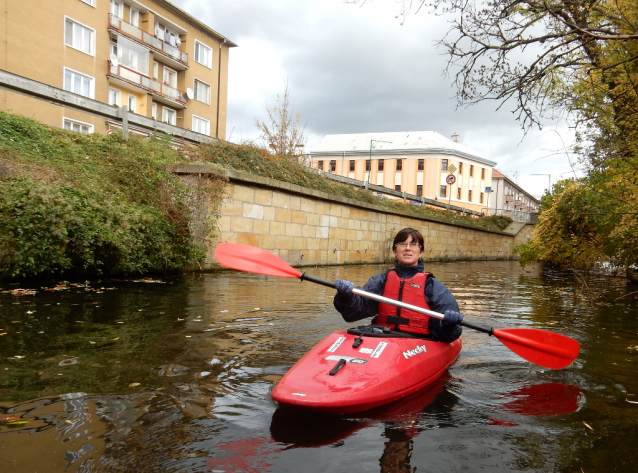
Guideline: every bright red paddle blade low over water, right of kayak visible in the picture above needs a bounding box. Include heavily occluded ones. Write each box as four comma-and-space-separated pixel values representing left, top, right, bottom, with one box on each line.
494, 328, 580, 370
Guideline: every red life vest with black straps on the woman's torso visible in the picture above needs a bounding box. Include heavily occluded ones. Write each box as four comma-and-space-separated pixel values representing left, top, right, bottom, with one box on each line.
376, 270, 430, 335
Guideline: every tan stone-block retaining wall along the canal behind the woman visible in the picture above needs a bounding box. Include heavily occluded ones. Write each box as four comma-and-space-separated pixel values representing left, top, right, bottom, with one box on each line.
171, 165, 533, 269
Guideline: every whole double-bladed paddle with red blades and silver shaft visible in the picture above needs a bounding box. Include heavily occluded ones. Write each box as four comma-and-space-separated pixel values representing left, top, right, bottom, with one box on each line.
215, 243, 580, 369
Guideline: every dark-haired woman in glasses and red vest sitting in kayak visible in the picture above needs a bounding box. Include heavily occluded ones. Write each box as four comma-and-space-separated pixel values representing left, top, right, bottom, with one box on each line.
334, 228, 463, 343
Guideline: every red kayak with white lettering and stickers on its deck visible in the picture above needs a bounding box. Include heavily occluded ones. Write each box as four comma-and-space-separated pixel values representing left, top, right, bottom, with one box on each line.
272, 329, 462, 414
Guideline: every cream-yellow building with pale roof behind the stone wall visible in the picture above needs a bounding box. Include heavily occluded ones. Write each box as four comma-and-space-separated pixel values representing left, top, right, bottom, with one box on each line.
309, 131, 496, 212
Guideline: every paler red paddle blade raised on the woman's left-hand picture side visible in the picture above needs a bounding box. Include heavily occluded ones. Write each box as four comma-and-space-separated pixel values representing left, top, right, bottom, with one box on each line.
215, 243, 301, 278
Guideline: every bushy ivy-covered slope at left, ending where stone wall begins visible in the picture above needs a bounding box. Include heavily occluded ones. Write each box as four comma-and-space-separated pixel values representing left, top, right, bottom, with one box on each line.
0, 112, 210, 277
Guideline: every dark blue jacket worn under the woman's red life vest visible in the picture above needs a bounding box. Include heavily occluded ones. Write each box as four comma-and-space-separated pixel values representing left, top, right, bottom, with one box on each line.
334, 262, 463, 343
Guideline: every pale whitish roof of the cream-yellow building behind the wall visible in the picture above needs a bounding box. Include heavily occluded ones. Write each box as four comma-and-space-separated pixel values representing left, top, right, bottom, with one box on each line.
310, 131, 496, 166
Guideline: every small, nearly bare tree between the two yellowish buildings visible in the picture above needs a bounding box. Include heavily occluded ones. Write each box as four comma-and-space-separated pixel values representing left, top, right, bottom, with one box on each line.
255, 83, 306, 160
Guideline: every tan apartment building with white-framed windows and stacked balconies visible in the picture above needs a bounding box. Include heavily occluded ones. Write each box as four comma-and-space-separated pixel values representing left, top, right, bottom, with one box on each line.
0, 0, 236, 139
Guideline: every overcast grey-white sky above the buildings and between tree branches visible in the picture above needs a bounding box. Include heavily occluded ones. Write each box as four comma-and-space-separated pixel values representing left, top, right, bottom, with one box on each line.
172, 0, 574, 195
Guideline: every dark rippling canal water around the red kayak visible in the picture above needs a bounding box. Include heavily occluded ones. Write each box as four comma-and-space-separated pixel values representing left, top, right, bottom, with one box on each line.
0, 262, 638, 473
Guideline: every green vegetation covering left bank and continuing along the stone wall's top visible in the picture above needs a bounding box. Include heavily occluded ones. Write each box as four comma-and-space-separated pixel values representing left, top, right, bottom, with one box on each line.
0, 113, 504, 278
